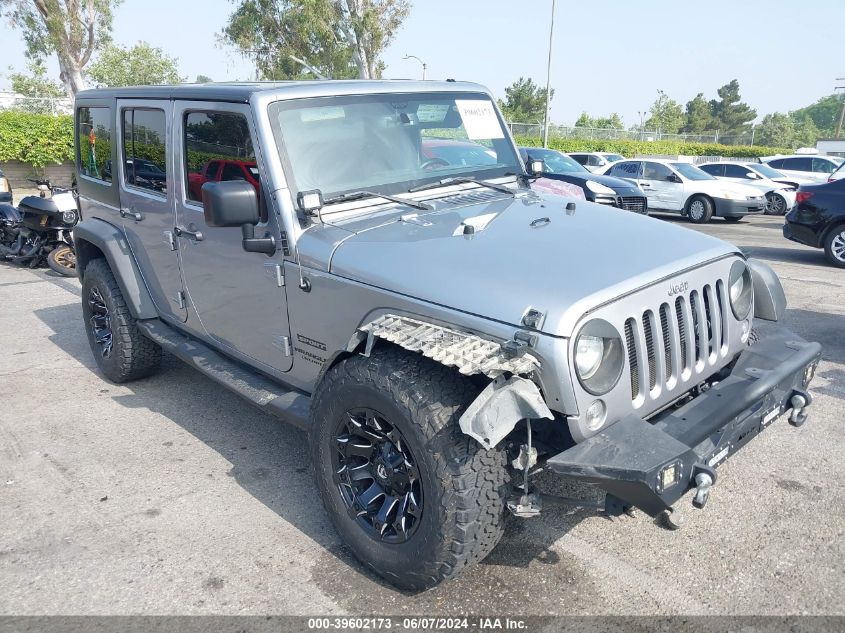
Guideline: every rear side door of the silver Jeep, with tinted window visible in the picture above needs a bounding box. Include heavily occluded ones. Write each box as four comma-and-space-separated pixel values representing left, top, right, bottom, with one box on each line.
112, 99, 188, 322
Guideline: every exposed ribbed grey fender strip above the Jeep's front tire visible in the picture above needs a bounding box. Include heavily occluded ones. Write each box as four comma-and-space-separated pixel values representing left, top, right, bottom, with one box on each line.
360, 314, 540, 378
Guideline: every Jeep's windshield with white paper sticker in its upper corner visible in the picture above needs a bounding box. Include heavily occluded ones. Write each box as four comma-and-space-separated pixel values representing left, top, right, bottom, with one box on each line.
269, 92, 523, 199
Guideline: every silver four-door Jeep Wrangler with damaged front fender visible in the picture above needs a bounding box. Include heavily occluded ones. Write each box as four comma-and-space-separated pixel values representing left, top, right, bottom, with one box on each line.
74, 81, 820, 588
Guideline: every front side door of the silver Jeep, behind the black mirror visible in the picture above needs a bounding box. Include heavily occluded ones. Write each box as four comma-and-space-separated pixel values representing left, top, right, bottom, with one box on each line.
173, 101, 293, 371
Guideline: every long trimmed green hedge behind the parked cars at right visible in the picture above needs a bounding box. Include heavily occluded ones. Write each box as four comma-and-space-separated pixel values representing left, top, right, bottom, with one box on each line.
516, 136, 792, 158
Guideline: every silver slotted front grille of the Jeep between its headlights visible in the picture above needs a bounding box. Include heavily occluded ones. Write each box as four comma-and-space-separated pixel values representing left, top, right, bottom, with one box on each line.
625, 280, 730, 408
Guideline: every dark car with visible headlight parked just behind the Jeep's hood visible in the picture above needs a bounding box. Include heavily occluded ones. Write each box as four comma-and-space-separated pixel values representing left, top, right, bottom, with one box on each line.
519, 147, 648, 215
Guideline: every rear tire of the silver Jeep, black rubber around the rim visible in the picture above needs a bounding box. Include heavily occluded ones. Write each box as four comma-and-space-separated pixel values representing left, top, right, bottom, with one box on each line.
82, 258, 161, 383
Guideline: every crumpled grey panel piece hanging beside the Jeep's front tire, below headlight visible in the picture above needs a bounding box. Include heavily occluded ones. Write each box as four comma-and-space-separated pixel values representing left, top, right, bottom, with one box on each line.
459, 376, 554, 448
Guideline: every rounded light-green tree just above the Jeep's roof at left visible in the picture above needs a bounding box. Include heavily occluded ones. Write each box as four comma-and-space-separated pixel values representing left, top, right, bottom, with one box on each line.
88, 42, 182, 87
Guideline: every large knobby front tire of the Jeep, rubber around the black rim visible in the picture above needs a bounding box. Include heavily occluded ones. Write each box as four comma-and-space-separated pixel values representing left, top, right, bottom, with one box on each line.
309, 347, 511, 590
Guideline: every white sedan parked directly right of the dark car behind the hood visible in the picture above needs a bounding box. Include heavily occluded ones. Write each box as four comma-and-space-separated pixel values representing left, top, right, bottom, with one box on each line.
607, 158, 766, 224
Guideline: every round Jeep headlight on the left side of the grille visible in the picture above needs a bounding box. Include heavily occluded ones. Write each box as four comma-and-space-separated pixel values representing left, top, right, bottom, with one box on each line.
574, 319, 625, 396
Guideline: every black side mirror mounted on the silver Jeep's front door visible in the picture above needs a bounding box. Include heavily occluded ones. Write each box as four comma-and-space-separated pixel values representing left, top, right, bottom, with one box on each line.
202, 180, 276, 255
